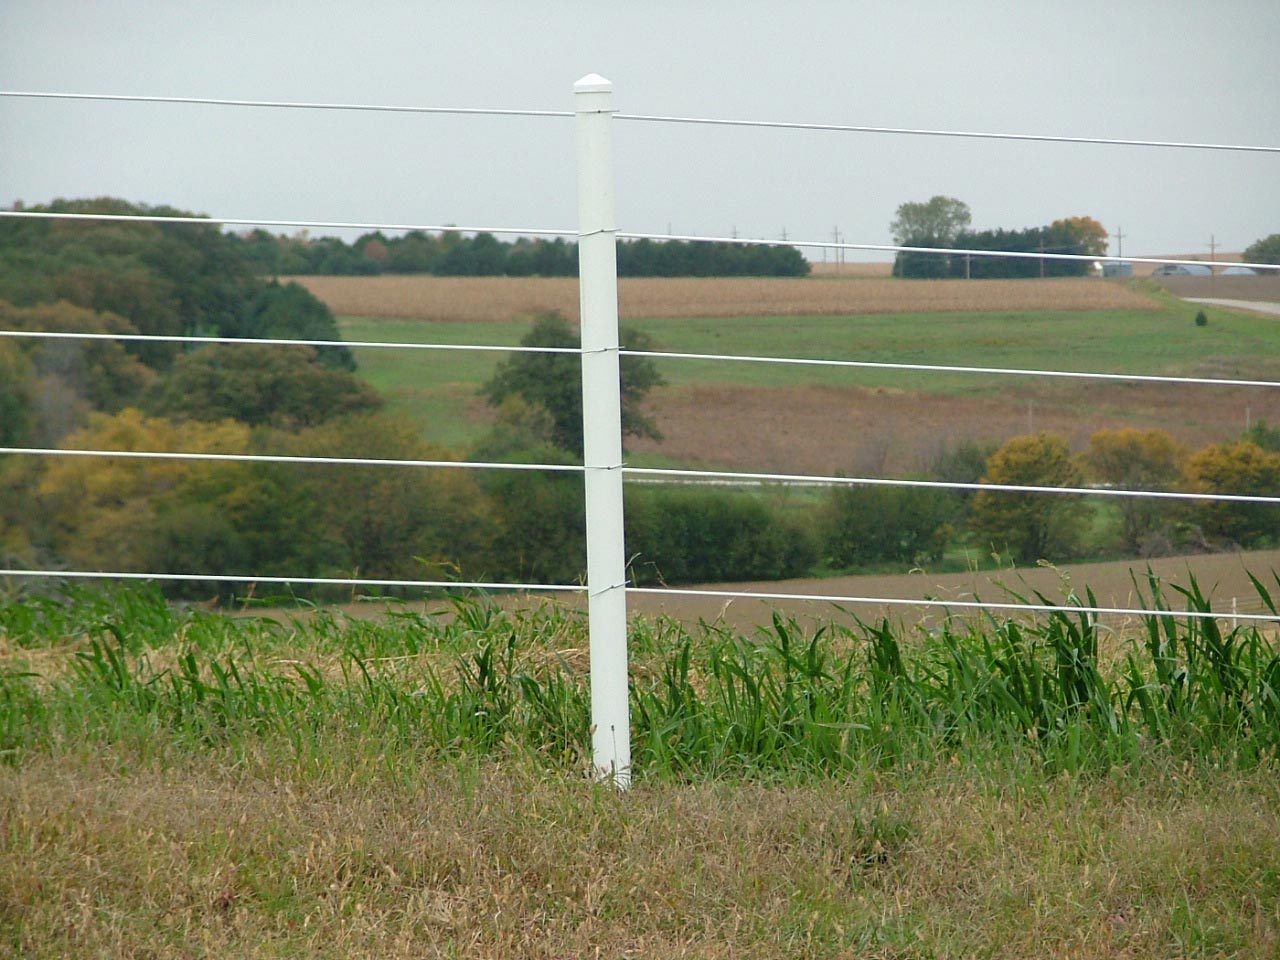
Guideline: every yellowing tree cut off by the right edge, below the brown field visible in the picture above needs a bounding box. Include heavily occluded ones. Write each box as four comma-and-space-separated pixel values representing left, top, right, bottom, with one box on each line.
1187, 440, 1280, 547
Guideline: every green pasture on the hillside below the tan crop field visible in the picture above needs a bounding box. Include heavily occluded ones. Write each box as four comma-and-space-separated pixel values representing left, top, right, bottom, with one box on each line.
339, 298, 1280, 447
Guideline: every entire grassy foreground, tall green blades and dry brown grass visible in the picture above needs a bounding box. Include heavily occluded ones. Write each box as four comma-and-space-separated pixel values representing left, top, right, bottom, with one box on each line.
0, 584, 1280, 957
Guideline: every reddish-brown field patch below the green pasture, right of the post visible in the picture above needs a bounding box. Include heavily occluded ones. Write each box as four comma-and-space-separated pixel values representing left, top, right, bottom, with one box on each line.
628, 381, 1280, 476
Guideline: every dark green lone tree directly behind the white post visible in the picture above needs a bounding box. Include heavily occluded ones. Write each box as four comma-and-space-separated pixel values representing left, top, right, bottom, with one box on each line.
481, 312, 666, 457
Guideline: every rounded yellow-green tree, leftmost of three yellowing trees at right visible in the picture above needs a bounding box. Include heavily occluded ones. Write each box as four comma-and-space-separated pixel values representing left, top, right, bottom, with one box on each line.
970, 433, 1088, 563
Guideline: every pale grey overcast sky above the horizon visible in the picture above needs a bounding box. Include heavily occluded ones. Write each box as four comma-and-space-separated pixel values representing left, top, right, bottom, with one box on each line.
0, 0, 1280, 260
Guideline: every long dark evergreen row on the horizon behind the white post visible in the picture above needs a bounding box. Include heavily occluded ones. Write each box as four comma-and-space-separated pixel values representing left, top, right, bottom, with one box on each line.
237, 230, 809, 276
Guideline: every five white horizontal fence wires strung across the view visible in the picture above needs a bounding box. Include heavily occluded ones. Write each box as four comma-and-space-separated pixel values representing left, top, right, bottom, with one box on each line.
0, 84, 1280, 632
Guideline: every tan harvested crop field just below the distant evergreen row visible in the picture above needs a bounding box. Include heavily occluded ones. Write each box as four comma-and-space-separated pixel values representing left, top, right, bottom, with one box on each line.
292, 273, 1156, 321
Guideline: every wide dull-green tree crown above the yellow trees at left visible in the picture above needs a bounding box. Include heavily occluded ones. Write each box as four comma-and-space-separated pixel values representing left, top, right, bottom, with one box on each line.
147, 343, 383, 429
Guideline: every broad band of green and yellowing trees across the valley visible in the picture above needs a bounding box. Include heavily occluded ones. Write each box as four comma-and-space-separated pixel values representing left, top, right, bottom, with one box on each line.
0, 201, 1280, 595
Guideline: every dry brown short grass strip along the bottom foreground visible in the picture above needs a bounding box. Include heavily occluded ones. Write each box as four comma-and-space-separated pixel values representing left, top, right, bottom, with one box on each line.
0, 754, 1280, 960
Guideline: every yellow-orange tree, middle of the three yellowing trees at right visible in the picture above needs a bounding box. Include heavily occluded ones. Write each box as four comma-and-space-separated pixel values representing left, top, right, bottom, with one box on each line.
1087, 428, 1187, 553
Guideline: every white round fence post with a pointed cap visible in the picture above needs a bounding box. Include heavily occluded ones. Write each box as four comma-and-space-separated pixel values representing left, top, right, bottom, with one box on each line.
573, 73, 631, 788
